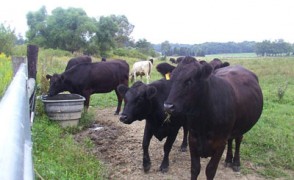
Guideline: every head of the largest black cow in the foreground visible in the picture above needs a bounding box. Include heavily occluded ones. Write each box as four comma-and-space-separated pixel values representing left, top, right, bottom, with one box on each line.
164, 59, 213, 113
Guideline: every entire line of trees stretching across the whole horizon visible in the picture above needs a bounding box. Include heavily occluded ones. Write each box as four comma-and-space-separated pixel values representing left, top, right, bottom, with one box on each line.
0, 6, 294, 58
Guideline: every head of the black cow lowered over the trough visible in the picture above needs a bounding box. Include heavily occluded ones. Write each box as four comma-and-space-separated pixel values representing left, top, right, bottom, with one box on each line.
46, 74, 65, 96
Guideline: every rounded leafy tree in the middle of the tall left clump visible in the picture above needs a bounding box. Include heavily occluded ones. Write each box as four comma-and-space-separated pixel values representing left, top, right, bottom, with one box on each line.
46, 8, 96, 53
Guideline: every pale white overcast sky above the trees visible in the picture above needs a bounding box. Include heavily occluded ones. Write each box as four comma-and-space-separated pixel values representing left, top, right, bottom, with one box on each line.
0, 0, 294, 44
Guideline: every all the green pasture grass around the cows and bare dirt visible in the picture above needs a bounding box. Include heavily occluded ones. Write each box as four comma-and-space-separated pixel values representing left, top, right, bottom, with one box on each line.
33, 52, 294, 179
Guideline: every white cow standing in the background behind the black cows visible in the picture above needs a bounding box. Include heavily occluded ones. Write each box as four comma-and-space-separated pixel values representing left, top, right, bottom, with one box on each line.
130, 61, 152, 84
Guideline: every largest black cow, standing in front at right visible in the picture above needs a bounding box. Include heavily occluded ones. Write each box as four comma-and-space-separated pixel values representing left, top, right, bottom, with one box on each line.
164, 57, 263, 179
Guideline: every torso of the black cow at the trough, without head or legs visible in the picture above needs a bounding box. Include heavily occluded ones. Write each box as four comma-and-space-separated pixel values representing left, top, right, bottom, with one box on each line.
62, 60, 129, 93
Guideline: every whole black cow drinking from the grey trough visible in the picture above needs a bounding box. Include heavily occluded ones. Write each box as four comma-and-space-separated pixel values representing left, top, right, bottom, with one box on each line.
46, 60, 129, 114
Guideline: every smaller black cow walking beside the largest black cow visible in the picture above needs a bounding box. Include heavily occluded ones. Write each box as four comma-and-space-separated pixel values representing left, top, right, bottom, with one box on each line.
118, 79, 188, 172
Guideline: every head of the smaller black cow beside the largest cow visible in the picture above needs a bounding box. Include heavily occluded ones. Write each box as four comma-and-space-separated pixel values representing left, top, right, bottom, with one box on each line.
117, 81, 157, 124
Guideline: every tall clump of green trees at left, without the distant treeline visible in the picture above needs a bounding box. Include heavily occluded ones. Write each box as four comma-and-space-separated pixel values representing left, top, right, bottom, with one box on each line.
0, 6, 156, 58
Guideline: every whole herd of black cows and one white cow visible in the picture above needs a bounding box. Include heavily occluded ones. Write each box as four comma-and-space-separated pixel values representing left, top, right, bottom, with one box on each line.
47, 56, 263, 179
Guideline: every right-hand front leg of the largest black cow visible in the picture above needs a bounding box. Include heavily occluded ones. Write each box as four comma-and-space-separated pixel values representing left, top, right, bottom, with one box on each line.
205, 144, 226, 180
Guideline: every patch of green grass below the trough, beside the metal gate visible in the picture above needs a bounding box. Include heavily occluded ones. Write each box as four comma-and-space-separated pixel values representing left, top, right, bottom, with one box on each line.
32, 102, 105, 180
